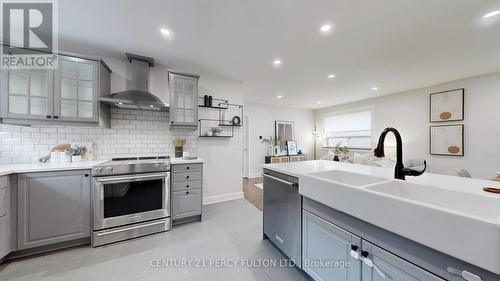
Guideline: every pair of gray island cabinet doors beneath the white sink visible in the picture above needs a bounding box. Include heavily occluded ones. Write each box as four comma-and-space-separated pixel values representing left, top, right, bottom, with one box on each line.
302, 210, 444, 281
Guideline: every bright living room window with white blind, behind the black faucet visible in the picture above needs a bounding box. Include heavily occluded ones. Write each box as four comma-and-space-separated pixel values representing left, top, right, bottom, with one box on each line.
323, 110, 372, 149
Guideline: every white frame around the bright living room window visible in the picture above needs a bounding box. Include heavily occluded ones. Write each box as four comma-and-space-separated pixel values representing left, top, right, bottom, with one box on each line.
321, 106, 375, 150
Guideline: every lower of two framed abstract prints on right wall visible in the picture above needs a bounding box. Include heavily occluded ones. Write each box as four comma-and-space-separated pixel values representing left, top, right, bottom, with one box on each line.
429, 125, 464, 156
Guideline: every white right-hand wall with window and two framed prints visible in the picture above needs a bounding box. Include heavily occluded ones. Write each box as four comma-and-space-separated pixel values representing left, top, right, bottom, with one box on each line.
315, 73, 500, 179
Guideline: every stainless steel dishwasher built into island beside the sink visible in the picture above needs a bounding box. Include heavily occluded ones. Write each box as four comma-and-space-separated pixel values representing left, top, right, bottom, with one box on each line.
263, 169, 302, 268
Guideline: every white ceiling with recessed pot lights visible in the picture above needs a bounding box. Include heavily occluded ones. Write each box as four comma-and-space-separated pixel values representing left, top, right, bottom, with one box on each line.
58, 0, 500, 108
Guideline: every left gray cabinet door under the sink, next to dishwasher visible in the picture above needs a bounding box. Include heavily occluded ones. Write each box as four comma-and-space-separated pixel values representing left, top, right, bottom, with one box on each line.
302, 211, 361, 281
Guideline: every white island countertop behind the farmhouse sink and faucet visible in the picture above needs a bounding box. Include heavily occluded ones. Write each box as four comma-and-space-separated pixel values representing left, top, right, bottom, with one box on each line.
263, 160, 500, 198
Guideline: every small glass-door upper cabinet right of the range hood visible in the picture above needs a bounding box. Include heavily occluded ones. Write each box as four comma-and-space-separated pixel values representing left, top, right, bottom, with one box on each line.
168, 71, 199, 129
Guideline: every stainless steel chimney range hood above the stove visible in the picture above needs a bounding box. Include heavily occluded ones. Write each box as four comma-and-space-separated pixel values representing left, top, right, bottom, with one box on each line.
99, 53, 168, 111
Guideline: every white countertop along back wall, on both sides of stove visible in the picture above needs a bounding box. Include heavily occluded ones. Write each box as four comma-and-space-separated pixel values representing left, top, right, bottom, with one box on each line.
0, 158, 203, 176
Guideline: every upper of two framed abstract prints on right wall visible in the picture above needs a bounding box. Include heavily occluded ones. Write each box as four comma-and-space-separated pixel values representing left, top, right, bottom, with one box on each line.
430, 88, 464, 123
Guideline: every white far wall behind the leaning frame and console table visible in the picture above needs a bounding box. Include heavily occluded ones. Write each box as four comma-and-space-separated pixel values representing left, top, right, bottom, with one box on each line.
245, 103, 314, 178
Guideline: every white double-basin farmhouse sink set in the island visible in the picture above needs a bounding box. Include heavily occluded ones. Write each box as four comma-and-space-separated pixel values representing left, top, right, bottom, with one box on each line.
299, 170, 500, 274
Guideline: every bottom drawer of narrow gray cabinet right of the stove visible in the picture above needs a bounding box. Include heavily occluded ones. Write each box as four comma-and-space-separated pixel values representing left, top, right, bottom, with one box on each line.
172, 189, 202, 220
